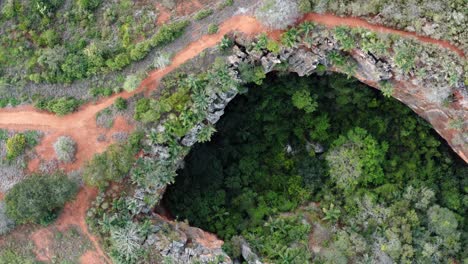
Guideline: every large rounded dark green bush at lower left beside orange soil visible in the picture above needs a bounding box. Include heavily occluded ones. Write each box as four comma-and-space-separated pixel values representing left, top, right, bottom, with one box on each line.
5, 174, 78, 224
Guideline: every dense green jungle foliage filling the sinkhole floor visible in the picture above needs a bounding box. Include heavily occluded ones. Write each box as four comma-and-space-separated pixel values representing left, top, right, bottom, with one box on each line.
164, 72, 468, 263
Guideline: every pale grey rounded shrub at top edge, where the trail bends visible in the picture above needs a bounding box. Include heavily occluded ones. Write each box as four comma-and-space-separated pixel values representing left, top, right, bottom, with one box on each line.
255, 0, 300, 29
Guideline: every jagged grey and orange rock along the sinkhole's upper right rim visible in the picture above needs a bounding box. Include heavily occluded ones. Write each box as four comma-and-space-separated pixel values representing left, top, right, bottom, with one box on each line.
226, 37, 468, 162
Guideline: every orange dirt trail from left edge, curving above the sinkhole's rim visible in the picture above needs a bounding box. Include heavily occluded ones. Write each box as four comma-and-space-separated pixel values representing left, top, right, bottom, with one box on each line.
0, 13, 464, 170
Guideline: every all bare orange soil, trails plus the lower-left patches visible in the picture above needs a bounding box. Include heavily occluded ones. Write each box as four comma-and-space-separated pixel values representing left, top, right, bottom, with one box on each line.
0, 12, 464, 264
